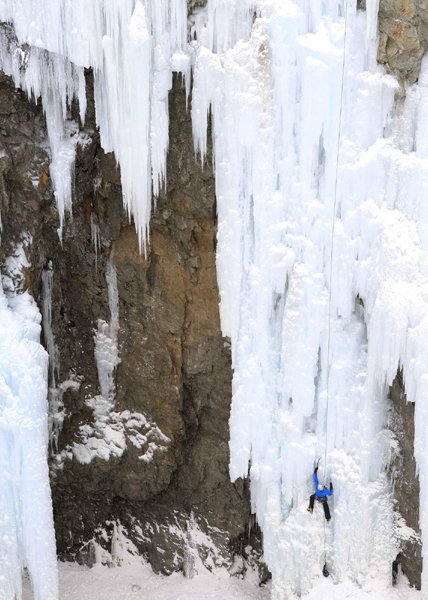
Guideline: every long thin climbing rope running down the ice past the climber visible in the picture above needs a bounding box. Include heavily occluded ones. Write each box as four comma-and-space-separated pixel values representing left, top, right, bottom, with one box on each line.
318, 0, 349, 577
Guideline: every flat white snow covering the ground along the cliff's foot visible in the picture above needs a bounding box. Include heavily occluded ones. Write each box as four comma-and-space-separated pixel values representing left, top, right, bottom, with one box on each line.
23, 558, 421, 600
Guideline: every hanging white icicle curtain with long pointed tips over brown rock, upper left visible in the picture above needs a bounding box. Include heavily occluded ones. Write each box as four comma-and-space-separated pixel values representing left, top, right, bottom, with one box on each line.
0, 0, 190, 248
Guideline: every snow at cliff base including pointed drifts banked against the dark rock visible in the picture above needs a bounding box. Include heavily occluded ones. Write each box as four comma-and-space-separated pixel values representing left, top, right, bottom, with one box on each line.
19, 522, 421, 600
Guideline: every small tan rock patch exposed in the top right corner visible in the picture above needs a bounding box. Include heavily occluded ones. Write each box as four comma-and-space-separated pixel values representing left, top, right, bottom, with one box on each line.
378, 0, 428, 86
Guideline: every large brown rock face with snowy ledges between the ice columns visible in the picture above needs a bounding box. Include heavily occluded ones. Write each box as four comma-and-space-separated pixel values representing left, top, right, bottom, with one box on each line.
0, 67, 260, 573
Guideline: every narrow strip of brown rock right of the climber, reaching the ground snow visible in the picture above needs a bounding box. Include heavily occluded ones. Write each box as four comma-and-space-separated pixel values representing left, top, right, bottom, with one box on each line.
390, 373, 422, 589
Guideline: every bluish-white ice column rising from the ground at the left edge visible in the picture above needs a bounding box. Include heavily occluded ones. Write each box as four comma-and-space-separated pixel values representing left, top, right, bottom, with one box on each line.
0, 288, 58, 600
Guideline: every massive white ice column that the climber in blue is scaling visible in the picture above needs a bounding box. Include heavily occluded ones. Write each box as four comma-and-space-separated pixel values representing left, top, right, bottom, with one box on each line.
192, 0, 428, 598
